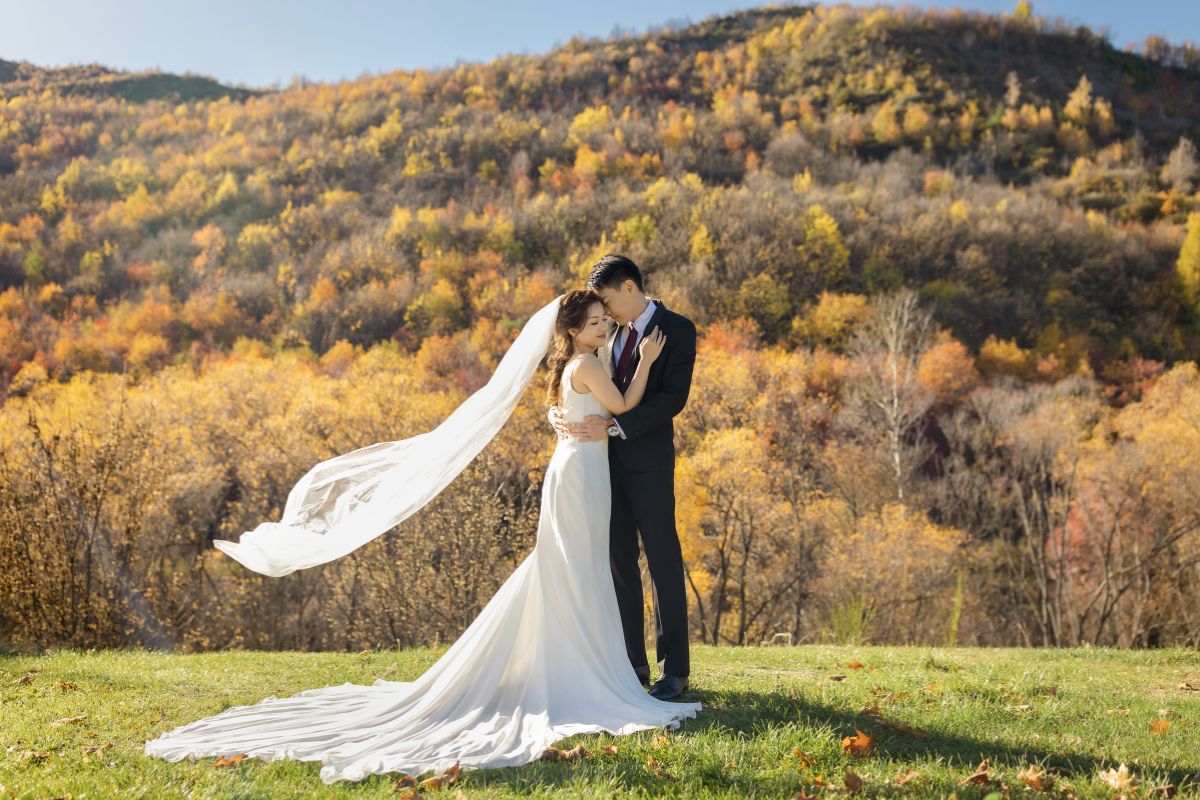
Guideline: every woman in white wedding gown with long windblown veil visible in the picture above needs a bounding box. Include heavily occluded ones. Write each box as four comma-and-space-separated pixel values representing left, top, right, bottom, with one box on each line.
145, 289, 700, 783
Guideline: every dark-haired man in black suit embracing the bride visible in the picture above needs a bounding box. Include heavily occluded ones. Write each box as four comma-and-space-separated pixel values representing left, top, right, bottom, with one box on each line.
551, 254, 696, 700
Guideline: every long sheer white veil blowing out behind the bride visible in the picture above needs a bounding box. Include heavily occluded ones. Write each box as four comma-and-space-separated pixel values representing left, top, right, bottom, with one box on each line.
212, 295, 564, 577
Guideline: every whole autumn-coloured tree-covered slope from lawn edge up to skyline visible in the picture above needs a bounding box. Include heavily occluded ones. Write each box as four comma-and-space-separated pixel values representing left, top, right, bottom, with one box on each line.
0, 2, 1200, 648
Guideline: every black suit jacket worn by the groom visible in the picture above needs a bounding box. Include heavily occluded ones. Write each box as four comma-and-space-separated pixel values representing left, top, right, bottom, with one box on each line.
608, 300, 696, 473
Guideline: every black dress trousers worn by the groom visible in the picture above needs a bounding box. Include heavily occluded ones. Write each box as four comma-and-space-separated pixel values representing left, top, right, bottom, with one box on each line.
608, 458, 690, 678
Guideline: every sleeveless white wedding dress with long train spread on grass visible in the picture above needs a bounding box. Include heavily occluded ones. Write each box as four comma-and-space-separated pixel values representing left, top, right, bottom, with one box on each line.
145, 357, 701, 783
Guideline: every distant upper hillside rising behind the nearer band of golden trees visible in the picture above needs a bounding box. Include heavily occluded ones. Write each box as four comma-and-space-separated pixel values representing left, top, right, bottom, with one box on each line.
0, 6, 1200, 378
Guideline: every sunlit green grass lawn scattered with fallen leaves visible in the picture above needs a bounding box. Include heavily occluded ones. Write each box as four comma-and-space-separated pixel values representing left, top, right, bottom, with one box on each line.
0, 646, 1200, 800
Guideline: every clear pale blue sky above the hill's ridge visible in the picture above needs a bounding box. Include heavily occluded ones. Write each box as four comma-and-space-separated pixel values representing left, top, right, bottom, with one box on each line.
0, 0, 1200, 86
